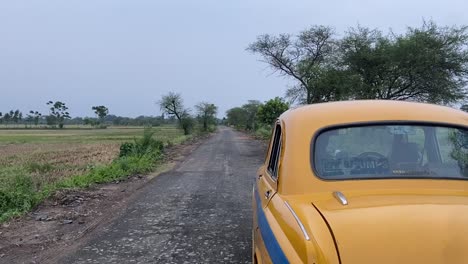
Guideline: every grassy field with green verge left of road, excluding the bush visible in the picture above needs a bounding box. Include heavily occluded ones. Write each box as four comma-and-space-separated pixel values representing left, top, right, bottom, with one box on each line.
0, 126, 187, 221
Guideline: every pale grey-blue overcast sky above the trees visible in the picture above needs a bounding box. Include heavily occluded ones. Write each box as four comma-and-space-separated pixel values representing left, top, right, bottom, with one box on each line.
0, 0, 468, 116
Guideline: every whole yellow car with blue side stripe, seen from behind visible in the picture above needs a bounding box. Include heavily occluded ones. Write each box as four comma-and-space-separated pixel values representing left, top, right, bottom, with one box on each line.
253, 101, 468, 264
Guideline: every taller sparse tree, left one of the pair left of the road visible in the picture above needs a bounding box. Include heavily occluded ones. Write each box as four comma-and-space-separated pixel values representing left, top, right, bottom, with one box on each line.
158, 92, 195, 135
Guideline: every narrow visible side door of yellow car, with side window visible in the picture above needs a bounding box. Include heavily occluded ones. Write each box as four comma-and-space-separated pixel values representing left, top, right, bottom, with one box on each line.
254, 123, 282, 262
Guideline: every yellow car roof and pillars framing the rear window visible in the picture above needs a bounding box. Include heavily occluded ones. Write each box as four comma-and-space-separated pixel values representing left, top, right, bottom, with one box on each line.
278, 100, 468, 194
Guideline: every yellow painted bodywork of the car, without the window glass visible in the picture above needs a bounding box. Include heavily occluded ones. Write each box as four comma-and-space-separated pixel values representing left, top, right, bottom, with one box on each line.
253, 101, 468, 264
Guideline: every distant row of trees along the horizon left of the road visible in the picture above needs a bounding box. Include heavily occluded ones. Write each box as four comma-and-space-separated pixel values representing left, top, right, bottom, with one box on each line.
0, 97, 221, 130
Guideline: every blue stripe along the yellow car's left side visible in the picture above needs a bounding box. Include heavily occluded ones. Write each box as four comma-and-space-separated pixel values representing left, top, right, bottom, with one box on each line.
255, 188, 289, 263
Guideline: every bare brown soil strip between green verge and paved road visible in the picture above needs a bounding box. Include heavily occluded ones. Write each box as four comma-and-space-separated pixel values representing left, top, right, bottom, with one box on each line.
0, 138, 207, 263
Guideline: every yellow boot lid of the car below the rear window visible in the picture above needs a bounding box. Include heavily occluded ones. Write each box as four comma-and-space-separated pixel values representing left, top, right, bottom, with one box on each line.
315, 192, 468, 263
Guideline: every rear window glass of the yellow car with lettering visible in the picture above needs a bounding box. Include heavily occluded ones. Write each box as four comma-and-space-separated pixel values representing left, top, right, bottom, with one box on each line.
311, 124, 468, 179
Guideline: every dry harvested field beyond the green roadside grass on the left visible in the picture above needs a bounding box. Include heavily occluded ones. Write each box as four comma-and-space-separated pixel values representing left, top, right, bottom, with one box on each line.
0, 126, 184, 189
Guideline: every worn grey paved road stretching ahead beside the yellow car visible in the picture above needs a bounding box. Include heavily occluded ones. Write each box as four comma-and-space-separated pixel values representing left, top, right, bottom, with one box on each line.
59, 128, 264, 263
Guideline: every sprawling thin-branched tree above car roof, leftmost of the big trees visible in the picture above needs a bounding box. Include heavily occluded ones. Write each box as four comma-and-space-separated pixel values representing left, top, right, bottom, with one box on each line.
247, 26, 337, 104
